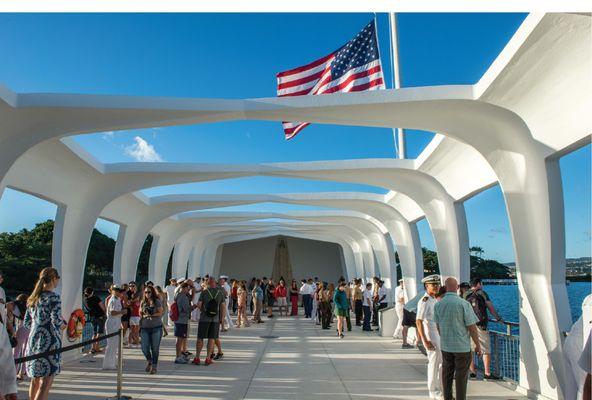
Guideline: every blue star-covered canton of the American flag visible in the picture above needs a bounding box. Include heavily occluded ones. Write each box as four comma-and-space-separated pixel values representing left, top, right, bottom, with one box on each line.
331, 21, 380, 80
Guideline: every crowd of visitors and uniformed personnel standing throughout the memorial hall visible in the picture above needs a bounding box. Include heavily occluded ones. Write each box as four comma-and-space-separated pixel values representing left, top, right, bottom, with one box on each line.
0, 268, 590, 400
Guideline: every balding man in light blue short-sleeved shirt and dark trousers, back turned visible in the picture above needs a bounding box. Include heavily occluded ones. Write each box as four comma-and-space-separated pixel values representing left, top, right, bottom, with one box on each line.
434, 277, 481, 400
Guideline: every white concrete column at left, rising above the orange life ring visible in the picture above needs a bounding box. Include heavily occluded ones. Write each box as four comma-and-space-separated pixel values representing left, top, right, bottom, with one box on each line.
52, 205, 98, 318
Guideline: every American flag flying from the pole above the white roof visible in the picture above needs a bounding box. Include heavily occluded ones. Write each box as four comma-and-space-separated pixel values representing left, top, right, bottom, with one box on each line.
277, 20, 385, 140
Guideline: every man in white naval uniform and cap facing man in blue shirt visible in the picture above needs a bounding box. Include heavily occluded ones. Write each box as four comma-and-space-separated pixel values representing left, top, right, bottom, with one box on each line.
416, 275, 442, 399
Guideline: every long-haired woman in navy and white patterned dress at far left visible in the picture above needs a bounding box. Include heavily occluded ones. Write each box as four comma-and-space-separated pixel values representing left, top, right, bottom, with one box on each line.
23, 267, 66, 400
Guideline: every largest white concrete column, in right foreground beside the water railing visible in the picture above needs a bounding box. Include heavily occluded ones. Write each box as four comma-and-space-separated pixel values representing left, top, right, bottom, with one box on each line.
496, 154, 571, 399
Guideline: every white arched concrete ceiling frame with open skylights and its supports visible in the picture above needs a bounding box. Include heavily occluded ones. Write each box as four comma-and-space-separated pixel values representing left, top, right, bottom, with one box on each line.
0, 14, 592, 399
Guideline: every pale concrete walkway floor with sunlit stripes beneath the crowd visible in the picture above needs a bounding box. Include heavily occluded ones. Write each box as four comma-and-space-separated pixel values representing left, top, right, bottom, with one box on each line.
19, 317, 524, 400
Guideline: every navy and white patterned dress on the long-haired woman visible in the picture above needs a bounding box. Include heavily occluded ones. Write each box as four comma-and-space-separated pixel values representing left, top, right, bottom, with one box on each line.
23, 292, 63, 378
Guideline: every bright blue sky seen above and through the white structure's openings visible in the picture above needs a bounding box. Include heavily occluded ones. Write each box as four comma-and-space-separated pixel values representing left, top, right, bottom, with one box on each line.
0, 13, 591, 261
